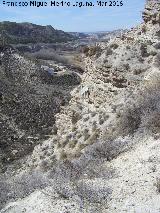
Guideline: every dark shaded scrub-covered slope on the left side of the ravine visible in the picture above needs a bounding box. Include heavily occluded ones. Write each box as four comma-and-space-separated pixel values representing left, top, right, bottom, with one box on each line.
0, 46, 80, 172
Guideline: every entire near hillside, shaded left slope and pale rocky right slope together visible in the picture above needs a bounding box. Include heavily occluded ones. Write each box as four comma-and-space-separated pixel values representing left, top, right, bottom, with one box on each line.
0, 0, 160, 213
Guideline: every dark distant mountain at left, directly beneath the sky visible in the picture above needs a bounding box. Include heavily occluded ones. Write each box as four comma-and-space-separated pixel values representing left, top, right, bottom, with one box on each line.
0, 21, 76, 44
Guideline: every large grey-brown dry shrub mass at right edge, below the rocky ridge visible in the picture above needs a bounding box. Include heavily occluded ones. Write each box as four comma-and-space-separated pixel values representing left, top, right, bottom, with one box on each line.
116, 82, 160, 135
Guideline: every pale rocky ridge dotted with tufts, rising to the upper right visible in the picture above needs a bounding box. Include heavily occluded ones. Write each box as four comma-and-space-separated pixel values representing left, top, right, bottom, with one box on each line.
52, 2, 160, 158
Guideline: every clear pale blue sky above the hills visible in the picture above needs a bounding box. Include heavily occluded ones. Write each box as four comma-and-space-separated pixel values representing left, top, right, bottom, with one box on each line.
0, 0, 145, 32
